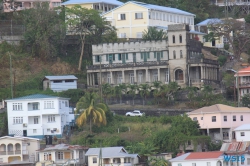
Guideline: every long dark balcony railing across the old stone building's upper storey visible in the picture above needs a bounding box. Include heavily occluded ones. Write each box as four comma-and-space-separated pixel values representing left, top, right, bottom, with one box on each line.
87, 61, 168, 70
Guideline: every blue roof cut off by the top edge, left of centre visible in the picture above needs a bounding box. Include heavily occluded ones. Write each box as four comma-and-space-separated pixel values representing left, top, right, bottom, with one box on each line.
62, 0, 123, 6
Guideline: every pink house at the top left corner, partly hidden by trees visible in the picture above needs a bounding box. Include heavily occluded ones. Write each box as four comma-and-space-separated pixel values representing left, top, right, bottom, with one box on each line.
3, 0, 61, 12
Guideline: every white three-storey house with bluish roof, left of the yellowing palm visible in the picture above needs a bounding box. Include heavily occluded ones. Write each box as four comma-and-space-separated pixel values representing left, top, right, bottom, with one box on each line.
6, 94, 74, 138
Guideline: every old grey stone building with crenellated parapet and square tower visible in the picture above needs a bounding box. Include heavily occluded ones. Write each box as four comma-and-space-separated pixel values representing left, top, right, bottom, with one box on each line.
87, 24, 219, 88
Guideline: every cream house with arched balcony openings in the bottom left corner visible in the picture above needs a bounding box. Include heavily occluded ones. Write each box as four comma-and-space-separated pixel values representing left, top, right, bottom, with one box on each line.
0, 136, 40, 166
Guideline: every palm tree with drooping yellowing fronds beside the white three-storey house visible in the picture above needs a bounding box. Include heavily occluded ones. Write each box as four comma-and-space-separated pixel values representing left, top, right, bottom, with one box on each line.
76, 92, 108, 133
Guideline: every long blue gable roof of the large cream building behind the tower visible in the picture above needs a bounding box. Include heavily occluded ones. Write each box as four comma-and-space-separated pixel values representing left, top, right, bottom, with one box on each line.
103, 1, 196, 17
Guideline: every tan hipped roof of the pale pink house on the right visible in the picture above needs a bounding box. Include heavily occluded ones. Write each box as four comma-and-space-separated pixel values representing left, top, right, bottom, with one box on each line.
188, 104, 250, 115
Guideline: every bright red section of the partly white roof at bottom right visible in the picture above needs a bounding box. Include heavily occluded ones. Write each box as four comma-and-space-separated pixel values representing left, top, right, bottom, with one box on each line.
185, 151, 224, 160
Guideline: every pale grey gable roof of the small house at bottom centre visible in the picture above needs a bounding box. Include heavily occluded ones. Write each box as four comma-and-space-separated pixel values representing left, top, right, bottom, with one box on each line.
85, 147, 138, 158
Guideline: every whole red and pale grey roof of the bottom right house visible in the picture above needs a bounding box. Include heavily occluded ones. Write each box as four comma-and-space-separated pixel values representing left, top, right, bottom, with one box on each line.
169, 151, 224, 162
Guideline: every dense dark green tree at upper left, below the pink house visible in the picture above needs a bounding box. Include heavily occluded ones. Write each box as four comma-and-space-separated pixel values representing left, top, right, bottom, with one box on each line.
15, 2, 65, 58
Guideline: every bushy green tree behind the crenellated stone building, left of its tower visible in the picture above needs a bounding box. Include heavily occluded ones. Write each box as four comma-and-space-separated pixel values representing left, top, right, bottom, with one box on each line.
142, 27, 168, 40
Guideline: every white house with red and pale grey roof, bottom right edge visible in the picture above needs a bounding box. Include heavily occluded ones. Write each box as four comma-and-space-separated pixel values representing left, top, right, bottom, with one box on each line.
169, 151, 224, 166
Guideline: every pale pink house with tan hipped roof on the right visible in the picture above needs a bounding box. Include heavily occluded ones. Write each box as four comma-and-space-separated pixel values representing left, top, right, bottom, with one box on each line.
187, 104, 250, 142
